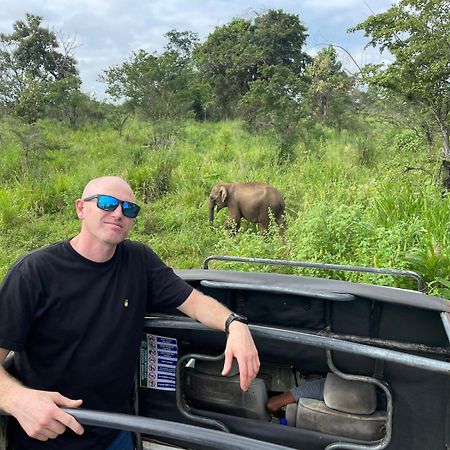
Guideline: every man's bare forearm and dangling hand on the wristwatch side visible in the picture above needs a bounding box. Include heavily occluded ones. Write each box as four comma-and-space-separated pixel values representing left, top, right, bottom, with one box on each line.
178, 289, 259, 391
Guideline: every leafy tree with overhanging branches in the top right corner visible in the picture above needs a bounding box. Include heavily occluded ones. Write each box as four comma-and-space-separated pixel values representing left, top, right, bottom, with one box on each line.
351, 0, 450, 158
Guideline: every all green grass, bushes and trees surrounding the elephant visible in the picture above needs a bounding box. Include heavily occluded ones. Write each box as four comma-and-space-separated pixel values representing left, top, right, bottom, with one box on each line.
0, 0, 450, 298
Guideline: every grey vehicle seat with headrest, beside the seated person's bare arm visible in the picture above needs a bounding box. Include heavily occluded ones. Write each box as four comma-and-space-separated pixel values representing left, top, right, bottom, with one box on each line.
286, 372, 387, 441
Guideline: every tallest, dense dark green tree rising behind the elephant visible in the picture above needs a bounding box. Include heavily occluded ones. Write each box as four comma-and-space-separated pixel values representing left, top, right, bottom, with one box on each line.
193, 10, 310, 118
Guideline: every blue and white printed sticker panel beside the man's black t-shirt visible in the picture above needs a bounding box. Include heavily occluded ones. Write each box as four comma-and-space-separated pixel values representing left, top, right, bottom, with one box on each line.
139, 334, 178, 391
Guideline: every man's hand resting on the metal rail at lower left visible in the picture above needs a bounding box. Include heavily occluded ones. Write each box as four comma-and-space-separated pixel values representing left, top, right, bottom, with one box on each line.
7, 386, 84, 441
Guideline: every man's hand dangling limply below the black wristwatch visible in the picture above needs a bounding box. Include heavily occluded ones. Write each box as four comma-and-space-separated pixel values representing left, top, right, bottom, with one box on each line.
222, 320, 259, 391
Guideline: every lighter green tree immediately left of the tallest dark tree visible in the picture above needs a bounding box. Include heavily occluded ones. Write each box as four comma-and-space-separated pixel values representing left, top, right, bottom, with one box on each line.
101, 30, 198, 120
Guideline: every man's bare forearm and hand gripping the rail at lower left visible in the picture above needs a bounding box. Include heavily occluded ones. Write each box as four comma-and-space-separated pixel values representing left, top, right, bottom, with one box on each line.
0, 348, 84, 441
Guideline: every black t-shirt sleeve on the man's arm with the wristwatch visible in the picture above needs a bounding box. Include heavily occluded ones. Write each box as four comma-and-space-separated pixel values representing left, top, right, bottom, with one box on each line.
147, 246, 193, 313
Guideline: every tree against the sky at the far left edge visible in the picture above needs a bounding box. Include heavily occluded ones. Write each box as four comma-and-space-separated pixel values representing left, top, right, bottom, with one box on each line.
0, 14, 81, 121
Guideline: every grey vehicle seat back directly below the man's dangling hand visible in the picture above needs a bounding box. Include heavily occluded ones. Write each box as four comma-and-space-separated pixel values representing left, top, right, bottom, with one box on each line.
185, 360, 270, 421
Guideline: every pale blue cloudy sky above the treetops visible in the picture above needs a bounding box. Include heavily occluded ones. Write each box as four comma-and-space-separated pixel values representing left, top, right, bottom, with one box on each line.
0, 0, 394, 100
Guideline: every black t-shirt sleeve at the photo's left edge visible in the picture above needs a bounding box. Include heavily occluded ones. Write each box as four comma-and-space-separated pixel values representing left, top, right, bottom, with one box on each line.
0, 266, 40, 351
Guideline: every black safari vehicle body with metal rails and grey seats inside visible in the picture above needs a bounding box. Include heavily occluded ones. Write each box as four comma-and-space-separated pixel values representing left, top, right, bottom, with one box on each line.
139, 258, 450, 450
